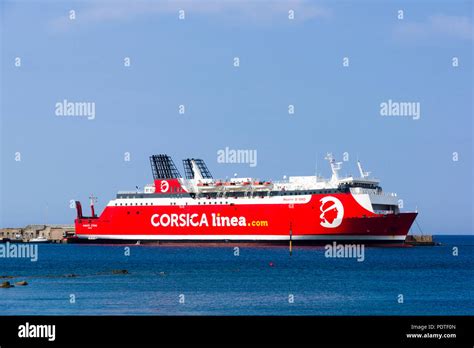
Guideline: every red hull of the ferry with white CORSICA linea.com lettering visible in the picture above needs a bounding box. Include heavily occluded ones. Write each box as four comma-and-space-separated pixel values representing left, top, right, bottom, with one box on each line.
75, 193, 417, 242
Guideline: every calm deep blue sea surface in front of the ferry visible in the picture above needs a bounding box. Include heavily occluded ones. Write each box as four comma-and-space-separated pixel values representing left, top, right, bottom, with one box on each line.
0, 236, 474, 315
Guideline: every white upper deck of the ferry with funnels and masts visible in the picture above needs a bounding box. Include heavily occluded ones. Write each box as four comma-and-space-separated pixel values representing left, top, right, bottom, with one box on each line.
117, 154, 396, 199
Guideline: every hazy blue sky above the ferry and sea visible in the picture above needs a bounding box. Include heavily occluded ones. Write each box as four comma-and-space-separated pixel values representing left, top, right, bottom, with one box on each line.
0, 0, 474, 234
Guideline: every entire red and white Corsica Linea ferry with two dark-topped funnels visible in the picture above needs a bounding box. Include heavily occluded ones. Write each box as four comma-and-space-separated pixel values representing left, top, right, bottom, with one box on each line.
75, 154, 417, 244
